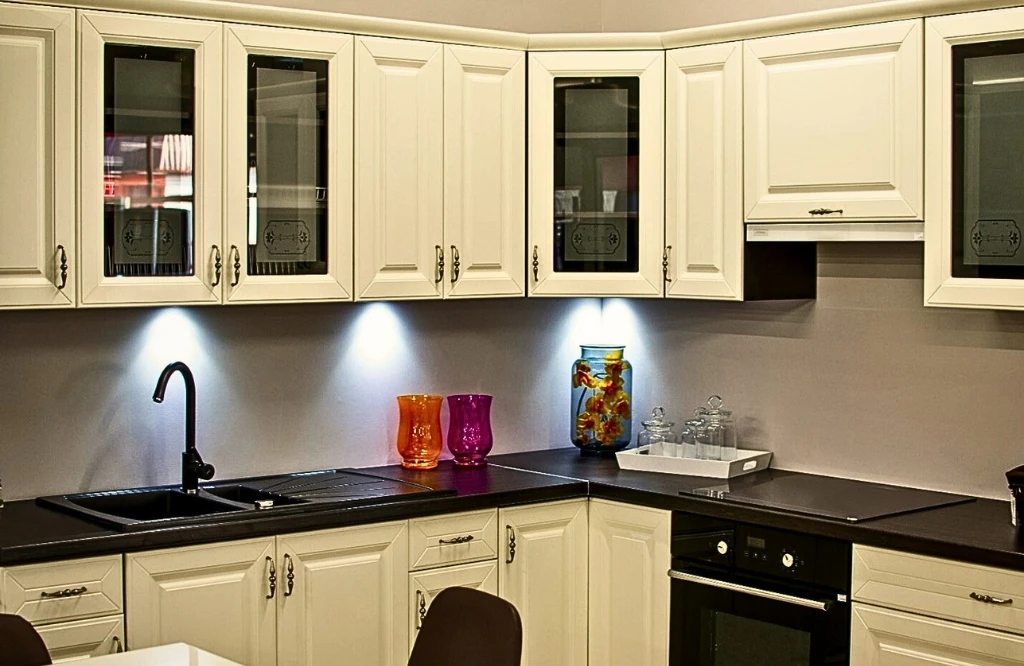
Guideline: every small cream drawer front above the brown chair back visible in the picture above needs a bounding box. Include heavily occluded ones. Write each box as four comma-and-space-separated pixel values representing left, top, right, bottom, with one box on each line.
409, 509, 498, 571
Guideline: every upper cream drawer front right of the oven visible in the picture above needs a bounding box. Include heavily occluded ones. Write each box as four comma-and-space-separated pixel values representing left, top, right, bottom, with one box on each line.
853, 546, 1024, 634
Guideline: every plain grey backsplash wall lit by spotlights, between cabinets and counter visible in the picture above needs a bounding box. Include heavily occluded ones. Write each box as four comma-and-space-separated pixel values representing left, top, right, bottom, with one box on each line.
0, 244, 1024, 498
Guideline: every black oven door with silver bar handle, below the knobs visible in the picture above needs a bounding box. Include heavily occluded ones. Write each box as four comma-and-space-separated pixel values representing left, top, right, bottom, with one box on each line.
669, 565, 850, 666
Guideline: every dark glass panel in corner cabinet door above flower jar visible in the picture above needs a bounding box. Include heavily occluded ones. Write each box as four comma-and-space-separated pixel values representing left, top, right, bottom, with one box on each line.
553, 77, 640, 273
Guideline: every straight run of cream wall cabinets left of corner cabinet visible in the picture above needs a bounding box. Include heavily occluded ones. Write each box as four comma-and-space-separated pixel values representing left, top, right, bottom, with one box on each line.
0, 3, 525, 306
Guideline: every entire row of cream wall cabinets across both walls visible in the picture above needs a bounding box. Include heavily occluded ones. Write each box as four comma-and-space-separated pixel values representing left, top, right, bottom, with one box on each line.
16, 3, 1024, 308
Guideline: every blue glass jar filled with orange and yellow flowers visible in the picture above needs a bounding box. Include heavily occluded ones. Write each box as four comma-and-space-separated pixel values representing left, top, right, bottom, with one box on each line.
571, 344, 633, 453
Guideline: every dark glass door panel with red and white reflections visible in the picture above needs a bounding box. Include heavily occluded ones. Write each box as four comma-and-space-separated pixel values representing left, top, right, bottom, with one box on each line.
103, 44, 196, 278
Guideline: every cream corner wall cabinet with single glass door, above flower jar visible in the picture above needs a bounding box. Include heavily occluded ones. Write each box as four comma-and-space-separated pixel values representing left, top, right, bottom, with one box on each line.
527, 51, 665, 296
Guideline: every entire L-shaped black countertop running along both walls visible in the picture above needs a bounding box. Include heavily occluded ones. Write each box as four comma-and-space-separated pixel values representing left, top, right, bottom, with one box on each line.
0, 449, 1024, 571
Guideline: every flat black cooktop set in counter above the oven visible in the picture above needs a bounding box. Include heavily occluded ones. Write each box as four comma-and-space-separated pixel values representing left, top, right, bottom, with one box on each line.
680, 469, 975, 523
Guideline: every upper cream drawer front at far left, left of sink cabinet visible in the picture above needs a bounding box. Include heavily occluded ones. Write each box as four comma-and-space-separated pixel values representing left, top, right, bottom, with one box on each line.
0, 555, 124, 624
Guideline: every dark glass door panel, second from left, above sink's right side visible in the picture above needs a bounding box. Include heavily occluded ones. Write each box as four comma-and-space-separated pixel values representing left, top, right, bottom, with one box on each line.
247, 55, 328, 276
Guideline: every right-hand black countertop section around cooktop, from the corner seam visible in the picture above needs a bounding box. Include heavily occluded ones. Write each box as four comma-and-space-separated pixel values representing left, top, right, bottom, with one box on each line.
492, 449, 1024, 571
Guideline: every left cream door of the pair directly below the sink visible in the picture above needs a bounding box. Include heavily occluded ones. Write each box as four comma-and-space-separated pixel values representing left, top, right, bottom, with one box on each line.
125, 538, 284, 666
